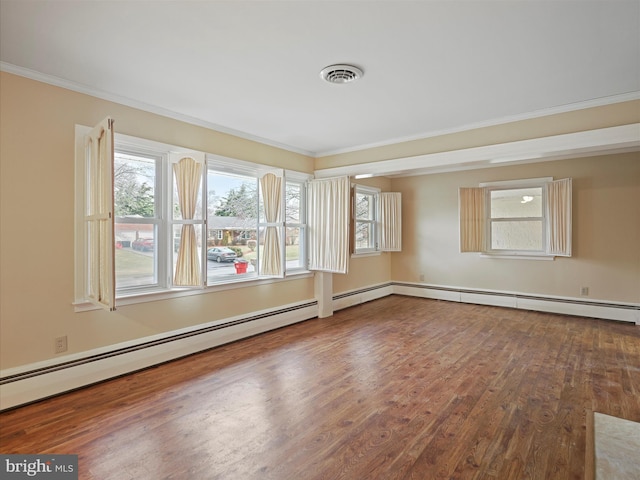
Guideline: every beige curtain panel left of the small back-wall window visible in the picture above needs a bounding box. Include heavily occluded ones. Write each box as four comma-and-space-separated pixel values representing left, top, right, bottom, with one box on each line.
458, 187, 486, 252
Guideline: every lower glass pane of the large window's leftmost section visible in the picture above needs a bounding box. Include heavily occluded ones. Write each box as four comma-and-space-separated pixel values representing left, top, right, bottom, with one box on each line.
115, 223, 158, 289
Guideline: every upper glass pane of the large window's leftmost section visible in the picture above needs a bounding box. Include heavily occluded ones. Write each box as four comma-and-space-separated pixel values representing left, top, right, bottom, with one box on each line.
113, 152, 156, 218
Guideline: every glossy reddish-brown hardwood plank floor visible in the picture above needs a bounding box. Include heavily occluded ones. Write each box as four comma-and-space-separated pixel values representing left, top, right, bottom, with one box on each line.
0, 296, 640, 480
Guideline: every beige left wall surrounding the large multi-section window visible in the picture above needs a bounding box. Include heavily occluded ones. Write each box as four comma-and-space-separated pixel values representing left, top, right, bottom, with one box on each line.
0, 73, 314, 369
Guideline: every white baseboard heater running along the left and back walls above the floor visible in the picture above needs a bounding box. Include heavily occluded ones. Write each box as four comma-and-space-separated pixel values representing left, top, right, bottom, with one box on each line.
0, 282, 640, 411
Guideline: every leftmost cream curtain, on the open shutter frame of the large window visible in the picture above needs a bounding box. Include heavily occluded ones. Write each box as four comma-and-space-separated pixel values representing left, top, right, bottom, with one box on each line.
85, 118, 116, 311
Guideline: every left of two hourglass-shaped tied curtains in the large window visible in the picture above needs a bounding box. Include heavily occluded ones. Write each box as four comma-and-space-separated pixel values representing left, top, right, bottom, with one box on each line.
173, 157, 202, 286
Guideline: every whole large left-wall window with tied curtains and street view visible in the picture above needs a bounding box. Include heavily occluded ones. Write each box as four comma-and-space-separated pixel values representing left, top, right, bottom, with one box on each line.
76, 121, 310, 307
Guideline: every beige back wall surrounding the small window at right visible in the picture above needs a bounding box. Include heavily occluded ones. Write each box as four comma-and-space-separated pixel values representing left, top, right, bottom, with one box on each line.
391, 153, 640, 303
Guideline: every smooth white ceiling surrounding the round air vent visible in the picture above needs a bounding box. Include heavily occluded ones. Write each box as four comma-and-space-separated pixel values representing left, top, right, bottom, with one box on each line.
0, 0, 640, 156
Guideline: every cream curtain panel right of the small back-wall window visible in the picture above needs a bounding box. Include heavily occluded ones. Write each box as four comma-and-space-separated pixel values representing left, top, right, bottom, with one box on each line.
547, 178, 572, 257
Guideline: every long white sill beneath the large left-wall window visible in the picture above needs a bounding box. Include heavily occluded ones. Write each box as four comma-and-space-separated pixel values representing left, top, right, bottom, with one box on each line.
73, 270, 313, 313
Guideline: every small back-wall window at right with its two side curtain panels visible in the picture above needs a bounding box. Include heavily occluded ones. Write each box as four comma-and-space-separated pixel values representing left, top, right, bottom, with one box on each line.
459, 178, 571, 257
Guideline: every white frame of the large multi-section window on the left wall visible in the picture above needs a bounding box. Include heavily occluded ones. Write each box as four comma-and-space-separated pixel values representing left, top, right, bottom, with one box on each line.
73, 125, 313, 312
